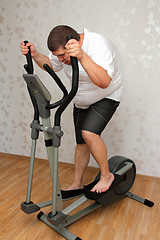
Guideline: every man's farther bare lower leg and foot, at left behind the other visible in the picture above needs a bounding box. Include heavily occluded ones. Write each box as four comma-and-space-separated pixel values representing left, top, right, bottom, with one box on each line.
64, 144, 90, 190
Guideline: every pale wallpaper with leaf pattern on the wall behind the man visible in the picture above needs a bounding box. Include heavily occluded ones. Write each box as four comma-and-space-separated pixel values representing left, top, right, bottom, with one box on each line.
0, 0, 160, 177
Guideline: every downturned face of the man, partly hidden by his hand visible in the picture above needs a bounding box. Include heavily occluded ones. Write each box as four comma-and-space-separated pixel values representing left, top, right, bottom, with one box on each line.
52, 46, 71, 65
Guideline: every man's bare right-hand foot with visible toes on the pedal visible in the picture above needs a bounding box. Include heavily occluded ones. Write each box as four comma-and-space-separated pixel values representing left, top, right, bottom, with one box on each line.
91, 173, 114, 193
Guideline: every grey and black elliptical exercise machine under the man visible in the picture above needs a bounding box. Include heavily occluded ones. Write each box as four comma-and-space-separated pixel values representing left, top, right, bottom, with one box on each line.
21, 36, 154, 240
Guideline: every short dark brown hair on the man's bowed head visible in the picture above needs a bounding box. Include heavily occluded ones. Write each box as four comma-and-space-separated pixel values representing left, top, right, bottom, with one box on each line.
47, 25, 80, 52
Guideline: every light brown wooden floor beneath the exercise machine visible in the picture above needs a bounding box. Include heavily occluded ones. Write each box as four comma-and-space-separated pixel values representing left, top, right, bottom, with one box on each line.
0, 154, 160, 240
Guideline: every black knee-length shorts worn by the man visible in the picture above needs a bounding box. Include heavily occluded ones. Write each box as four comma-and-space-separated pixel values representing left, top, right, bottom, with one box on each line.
73, 98, 119, 144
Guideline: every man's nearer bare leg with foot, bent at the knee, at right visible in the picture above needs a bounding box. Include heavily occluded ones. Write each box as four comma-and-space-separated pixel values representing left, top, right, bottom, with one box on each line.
82, 130, 114, 193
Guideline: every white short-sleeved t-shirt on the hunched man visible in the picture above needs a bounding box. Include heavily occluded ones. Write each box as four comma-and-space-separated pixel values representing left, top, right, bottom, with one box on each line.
49, 29, 123, 109
